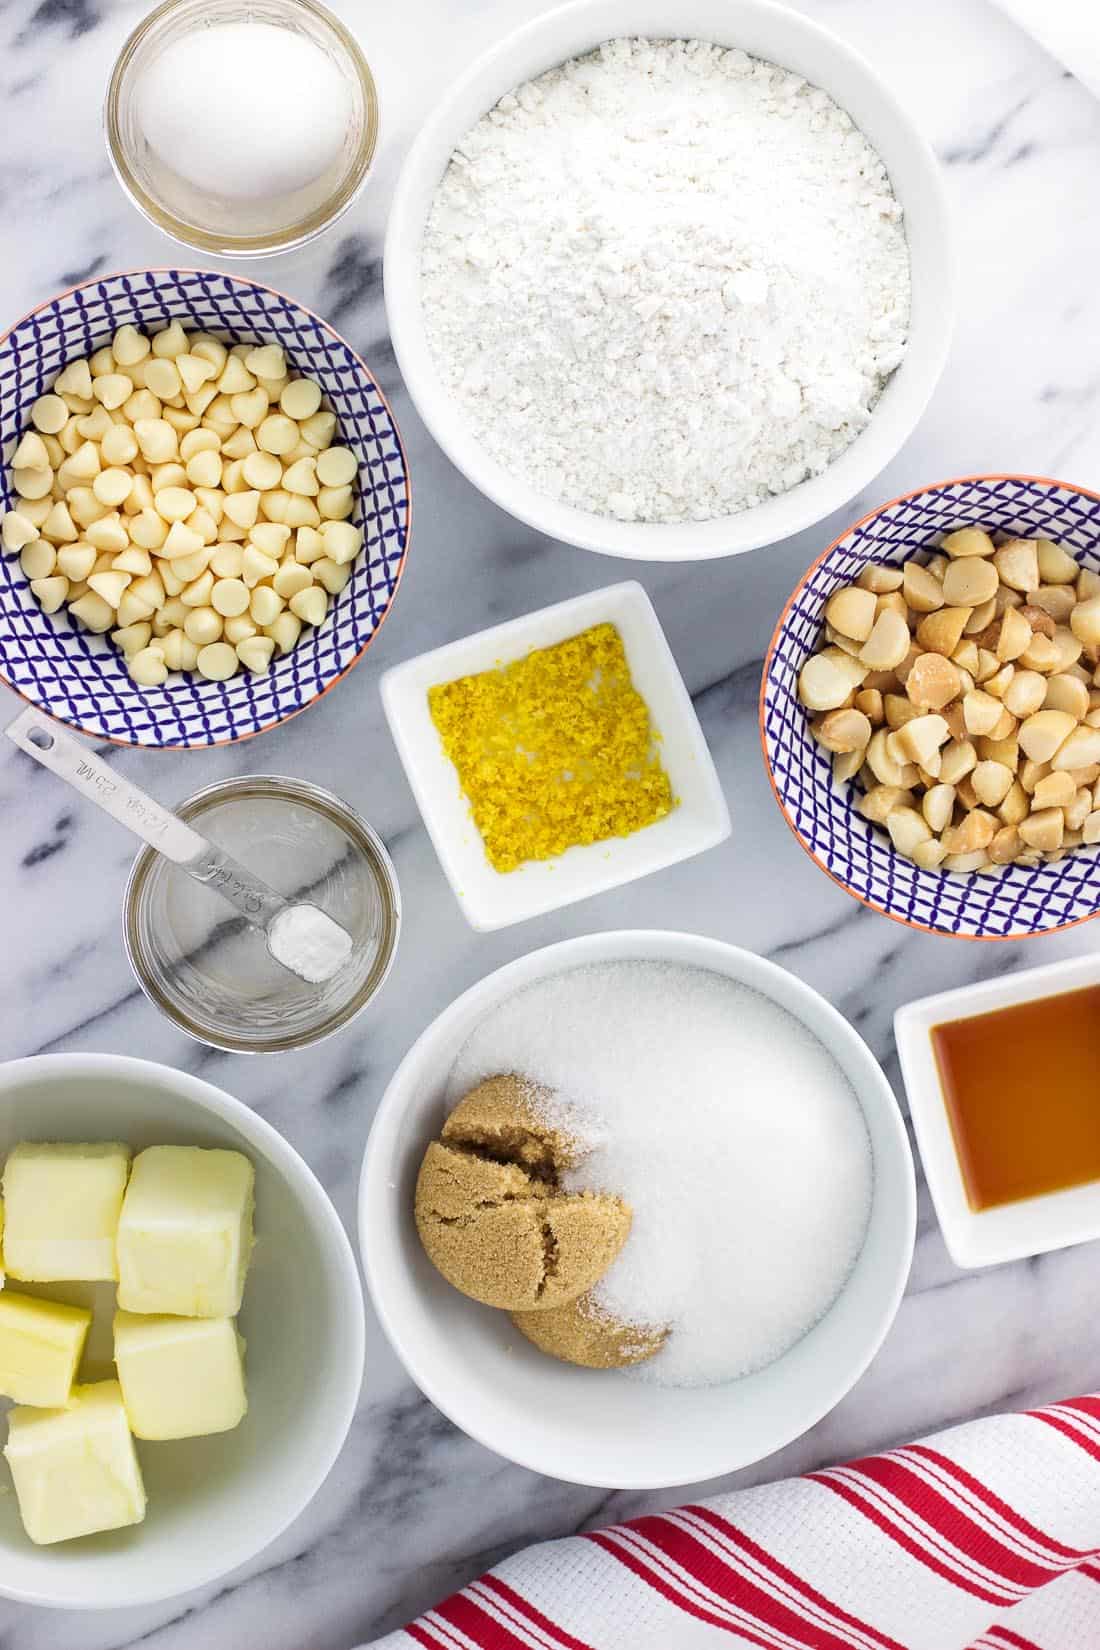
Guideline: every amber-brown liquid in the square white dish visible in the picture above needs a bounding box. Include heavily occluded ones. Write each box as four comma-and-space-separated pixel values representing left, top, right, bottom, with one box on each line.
932, 985, 1100, 1209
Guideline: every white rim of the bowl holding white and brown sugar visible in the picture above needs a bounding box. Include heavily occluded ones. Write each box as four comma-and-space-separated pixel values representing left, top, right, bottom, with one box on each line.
358, 929, 917, 1490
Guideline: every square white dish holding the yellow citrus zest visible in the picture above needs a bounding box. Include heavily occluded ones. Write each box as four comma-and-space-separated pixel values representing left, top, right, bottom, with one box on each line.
381, 579, 731, 932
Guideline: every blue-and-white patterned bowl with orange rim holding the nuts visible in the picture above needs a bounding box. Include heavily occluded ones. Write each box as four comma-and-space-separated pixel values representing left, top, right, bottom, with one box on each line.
760, 475, 1100, 939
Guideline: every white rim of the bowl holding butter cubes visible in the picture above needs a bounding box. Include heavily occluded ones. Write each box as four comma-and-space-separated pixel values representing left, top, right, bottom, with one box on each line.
0, 1051, 366, 1610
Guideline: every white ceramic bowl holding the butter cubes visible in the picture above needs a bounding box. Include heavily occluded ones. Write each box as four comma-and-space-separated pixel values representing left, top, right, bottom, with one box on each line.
0, 1054, 364, 1609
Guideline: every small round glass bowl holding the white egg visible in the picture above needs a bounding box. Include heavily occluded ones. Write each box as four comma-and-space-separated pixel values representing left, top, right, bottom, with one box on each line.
104, 0, 378, 257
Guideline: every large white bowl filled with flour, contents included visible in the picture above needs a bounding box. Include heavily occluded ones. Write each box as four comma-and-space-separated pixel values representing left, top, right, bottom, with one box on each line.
384, 0, 952, 561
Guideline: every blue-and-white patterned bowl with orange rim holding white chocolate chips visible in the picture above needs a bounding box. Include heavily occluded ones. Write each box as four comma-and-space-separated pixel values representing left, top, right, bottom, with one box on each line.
0, 269, 409, 749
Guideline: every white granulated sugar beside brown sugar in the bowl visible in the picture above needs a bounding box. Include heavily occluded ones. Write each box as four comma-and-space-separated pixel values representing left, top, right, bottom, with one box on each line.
450, 962, 872, 1386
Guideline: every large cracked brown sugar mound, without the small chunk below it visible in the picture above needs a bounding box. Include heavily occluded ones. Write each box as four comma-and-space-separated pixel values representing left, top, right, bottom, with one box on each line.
416, 1077, 630, 1313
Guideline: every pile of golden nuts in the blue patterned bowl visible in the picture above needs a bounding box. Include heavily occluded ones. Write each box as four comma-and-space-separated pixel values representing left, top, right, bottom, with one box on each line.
798, 526, 1100, 875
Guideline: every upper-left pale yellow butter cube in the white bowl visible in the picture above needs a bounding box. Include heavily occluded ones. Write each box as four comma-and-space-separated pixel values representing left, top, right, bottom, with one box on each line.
3, 1140, 130, 1284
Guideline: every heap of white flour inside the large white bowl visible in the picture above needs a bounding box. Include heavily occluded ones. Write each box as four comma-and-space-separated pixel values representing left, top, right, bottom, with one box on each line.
422, 40, 909, 521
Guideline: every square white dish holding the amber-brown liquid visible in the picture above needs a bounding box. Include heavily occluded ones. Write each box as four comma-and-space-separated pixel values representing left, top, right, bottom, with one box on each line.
894, 957, 1100, 1267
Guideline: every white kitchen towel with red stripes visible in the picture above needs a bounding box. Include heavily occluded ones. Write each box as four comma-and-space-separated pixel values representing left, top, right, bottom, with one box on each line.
373, 1394, 1100, 1650
